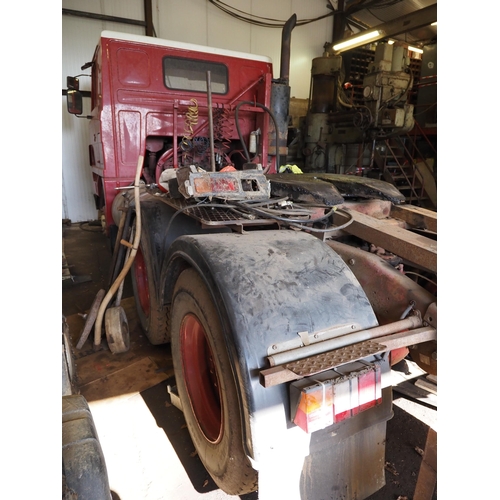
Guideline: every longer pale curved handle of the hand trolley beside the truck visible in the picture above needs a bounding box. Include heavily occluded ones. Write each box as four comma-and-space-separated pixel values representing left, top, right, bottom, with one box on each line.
94, 155, 144, 346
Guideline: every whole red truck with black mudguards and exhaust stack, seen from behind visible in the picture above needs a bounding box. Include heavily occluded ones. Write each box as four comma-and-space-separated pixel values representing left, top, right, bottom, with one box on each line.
68, 16, 437, 500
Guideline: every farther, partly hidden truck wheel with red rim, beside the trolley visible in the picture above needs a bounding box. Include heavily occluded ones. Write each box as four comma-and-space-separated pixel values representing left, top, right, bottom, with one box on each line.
131, 236, 170, 345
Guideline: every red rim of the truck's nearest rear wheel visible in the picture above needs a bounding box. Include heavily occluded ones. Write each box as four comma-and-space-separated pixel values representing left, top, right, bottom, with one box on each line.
180, 314, 222, 443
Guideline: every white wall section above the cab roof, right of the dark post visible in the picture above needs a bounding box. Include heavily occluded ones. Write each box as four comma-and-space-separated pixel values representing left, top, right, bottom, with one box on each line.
153, 0, 333, 98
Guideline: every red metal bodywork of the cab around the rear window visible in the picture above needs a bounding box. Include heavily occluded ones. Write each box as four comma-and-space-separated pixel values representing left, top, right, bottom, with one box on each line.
90, 31, 272, 227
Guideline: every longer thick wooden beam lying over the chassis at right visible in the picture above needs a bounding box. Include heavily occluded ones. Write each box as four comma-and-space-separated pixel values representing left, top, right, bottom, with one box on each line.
334, 210, 437, 272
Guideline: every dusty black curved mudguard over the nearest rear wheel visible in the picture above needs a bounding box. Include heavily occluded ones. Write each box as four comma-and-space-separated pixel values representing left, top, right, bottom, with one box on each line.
160, 230, 378, 462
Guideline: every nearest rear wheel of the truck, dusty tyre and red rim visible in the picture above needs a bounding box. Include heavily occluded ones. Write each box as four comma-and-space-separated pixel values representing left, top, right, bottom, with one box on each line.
171, 269, 257, 495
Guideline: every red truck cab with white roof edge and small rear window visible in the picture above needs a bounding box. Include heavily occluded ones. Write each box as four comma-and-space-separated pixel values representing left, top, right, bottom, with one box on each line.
84, 31, 275, 231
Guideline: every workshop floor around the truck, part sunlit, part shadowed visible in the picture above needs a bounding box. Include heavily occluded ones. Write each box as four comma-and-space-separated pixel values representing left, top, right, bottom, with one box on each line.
62, 223, 437, 500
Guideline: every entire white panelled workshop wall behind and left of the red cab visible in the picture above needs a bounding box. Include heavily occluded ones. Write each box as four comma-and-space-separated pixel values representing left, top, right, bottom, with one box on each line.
61, 0, 333, 222
